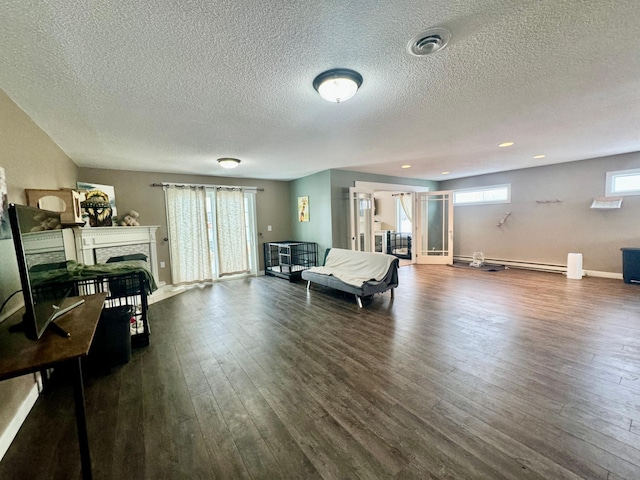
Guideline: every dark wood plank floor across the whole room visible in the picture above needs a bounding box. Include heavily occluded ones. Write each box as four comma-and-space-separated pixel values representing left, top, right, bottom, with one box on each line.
0, 266, 640, 480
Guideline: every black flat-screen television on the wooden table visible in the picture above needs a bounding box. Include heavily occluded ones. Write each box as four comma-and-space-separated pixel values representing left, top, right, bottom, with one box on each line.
9, 204, 84, 340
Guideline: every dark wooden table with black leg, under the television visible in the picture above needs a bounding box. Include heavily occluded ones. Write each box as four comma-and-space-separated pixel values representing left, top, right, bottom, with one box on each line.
0, 293, 106, 479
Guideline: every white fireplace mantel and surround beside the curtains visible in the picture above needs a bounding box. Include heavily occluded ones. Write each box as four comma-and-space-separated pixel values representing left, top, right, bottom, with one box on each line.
73, 225, 160, 285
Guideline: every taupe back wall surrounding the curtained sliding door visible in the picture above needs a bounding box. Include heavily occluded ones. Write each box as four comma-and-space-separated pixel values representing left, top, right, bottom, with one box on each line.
78, 167, 292, 283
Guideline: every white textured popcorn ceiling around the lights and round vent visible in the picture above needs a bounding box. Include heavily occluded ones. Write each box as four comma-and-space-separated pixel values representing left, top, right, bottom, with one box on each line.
0, 0, 640, 180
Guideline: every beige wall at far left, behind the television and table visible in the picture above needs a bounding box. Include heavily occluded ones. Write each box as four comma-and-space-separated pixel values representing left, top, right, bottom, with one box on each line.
0, 90, 77, 458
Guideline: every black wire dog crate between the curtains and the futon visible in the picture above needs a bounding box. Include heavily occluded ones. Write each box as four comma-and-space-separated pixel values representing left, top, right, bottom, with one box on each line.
264, 240, 318, 282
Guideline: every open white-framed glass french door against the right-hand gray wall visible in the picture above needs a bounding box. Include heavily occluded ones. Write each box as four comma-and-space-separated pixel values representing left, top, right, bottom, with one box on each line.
414, 191, 453, 265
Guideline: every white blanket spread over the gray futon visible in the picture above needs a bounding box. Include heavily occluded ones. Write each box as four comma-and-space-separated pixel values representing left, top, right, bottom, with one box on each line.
309, 248, 396, 287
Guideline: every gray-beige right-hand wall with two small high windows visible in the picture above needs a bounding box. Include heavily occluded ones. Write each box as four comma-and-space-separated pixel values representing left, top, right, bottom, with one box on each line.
440, 153, 640, 273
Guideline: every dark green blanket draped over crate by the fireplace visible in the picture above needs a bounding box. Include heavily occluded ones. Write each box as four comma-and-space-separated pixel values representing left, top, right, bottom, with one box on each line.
29, 260, 158, 294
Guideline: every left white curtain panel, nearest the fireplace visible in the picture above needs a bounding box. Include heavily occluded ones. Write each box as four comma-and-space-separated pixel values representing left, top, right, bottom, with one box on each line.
164, 186, 213, 284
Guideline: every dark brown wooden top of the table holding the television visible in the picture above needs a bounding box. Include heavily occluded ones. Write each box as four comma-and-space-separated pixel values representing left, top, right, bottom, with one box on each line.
0, 293, 106, 380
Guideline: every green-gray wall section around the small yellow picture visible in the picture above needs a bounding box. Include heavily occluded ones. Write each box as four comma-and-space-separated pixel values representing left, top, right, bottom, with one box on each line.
288, 170, 331, 263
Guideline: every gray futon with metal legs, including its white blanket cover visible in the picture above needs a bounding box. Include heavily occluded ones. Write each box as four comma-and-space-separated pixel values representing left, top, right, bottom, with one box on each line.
302, 248, 399, 308
